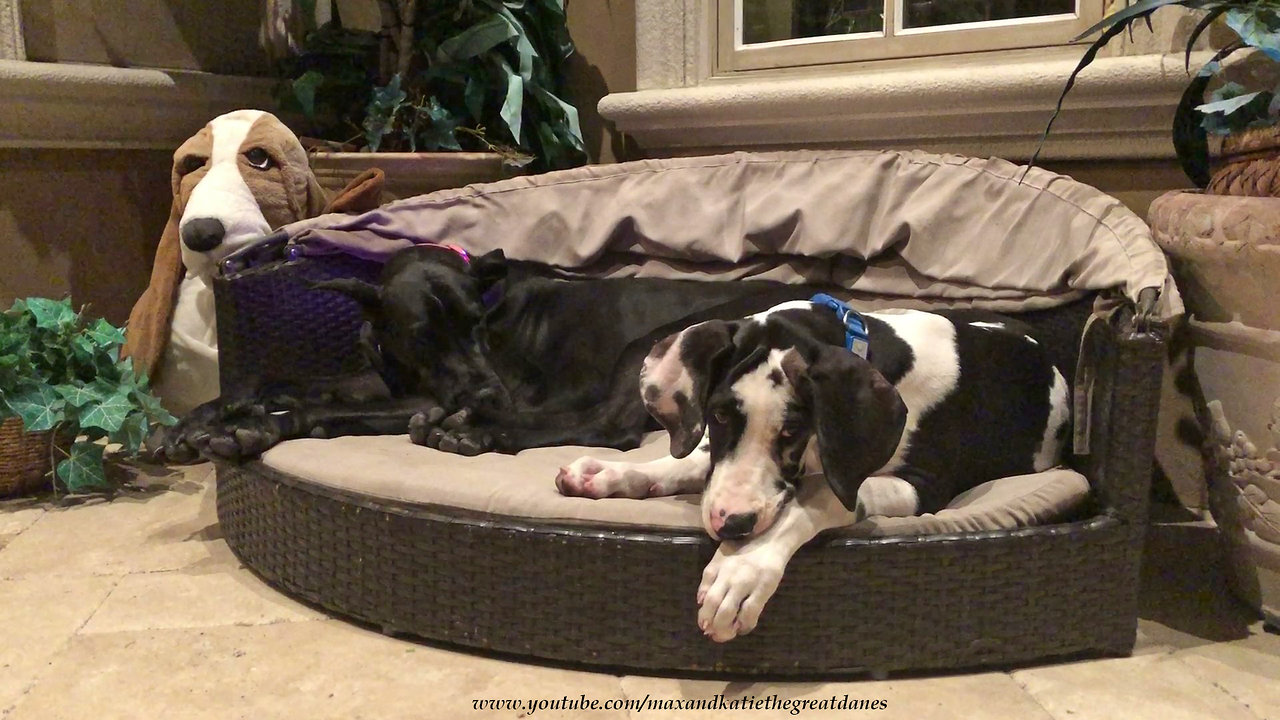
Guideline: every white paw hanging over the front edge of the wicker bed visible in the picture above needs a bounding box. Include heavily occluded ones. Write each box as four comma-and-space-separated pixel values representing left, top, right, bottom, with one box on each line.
698, 543, 786, 643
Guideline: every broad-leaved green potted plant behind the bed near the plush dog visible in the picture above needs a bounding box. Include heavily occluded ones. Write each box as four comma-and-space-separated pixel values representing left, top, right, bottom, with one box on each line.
279, 0, 586, 195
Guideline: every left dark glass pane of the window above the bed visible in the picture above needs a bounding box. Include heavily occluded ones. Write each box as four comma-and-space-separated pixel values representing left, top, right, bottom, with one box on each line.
739, 0, 880, 44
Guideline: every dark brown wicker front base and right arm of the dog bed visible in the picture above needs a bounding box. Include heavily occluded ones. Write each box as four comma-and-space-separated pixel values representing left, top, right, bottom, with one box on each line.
218, 292, 1164, 675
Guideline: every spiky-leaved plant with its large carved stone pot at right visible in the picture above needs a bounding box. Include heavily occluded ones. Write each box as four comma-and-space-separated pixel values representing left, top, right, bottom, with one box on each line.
1033, 0, 1280, 629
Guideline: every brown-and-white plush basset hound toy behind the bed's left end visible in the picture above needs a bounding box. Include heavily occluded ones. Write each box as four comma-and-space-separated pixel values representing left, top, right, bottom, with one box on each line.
123, 110, 384, 415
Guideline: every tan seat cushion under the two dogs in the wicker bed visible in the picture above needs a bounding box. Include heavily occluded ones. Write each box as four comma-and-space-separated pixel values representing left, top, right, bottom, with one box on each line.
262, 433, 1089, 536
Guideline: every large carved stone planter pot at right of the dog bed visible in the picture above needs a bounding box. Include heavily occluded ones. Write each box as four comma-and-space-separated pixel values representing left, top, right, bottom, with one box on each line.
1148, 192, 1280, 628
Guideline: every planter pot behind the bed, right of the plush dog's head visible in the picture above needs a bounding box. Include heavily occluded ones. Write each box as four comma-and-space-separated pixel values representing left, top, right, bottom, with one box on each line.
311, 151, 518, 200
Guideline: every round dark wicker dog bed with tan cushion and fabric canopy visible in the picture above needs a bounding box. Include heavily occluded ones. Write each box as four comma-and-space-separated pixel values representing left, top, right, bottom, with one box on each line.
216, 152, 1181, 675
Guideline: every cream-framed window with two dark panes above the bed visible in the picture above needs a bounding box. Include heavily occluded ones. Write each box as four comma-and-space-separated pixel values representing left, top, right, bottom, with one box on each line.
716, 0, 1105, 72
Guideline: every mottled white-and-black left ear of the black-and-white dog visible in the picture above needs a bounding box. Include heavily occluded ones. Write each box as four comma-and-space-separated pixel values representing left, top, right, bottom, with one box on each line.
640, 320, 737, 457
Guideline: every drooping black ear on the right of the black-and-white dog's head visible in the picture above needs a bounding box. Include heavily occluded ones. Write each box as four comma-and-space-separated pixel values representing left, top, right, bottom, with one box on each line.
782, 346, 906, 510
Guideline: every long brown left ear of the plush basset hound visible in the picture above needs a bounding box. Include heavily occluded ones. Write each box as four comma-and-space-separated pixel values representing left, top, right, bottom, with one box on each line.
120, 192, 183, 380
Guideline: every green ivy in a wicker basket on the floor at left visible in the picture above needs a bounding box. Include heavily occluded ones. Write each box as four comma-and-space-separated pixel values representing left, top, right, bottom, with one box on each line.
0, 297, 174, 495
